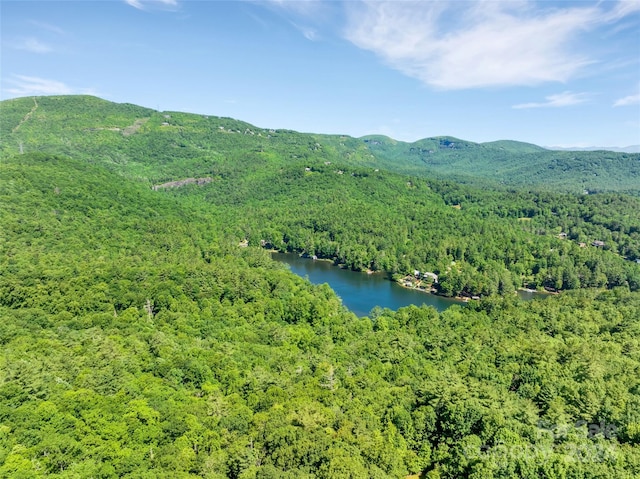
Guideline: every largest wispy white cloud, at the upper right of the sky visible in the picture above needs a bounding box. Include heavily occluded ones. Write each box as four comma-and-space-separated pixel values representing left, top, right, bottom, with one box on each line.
345, 0, 639, 89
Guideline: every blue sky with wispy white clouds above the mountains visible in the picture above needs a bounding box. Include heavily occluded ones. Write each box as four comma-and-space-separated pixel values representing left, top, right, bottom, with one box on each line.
0, 0, 640, 147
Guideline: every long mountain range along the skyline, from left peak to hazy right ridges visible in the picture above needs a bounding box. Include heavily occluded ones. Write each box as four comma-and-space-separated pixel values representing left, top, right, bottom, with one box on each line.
0, 96, 640, 194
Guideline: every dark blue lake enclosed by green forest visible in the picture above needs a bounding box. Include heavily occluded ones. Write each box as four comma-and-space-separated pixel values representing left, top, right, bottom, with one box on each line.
272, 253, 465, 316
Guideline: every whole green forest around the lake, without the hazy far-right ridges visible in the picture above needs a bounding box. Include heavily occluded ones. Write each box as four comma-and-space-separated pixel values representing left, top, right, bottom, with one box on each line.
0, 97, 640, 479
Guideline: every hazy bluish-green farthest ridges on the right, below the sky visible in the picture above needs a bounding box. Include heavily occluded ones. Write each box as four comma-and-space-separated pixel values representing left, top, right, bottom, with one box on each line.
364, 137, 640, 195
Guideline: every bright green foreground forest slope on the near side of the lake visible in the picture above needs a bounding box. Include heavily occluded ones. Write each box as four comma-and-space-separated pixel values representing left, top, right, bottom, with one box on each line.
0, 153, 640, 479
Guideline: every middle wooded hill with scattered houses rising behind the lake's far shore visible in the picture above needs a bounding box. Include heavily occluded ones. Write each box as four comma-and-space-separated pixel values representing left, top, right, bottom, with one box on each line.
169, 160, 640, 296
